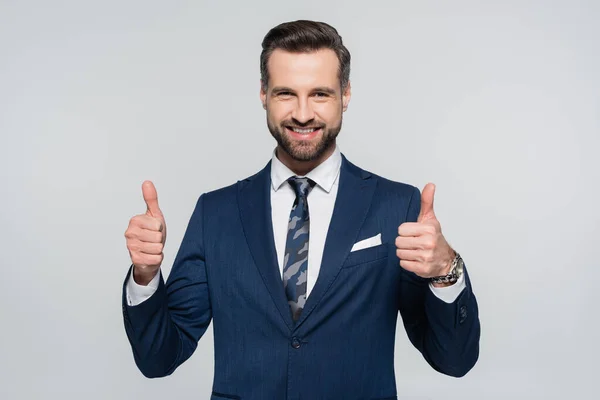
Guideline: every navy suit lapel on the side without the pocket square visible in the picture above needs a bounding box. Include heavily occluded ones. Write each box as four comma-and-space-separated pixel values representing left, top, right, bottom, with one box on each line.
238, 162, 294, 330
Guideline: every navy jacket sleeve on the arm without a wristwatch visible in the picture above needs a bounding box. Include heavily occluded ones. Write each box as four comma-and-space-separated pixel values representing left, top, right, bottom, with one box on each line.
122, 196, 212, 378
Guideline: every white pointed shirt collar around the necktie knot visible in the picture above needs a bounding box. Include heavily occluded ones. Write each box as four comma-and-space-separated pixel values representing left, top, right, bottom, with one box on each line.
271, 145, 342, 193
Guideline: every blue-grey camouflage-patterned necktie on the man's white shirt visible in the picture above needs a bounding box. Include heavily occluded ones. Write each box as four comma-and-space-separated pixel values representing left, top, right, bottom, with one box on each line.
283, 177, 315, 321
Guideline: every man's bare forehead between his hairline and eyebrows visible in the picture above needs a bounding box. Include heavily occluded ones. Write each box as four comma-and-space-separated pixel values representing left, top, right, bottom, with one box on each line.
267, 49, 339, 89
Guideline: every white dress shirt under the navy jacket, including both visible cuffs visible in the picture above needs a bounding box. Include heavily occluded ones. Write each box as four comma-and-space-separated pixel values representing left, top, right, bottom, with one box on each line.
126, 146, 466, 306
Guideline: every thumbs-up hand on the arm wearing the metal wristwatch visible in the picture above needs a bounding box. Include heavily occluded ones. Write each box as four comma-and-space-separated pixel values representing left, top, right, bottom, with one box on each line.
396, 183, 456, 286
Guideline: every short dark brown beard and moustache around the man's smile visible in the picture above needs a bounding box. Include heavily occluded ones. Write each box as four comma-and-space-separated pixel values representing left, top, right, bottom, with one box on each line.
267, 110, 342, 161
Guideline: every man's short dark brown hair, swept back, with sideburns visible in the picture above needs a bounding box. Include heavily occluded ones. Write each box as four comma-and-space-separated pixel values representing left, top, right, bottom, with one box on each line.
260, 20, 350, 92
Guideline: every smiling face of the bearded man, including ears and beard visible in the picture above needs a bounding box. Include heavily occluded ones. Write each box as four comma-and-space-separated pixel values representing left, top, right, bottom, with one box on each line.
260, 49, 350, 162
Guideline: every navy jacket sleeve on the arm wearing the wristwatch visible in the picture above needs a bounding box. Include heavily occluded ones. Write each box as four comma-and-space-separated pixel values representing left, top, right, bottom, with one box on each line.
398, 188, 480, 377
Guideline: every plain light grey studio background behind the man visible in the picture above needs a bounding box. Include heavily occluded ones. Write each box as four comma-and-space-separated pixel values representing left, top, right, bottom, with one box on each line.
0, 0, 600, 400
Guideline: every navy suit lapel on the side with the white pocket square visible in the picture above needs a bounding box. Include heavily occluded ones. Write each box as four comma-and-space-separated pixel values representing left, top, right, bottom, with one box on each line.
294, 155, 377, 329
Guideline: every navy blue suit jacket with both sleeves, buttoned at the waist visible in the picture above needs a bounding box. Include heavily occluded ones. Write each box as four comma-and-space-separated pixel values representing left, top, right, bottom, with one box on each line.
123, 157, 480, 400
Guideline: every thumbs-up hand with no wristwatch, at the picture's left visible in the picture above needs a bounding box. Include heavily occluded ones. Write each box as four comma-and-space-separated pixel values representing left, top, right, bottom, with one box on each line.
125, 181, 167, 285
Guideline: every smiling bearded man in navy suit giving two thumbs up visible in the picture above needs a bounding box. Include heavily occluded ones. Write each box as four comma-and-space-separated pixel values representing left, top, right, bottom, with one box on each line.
123, 21, 480, 400
